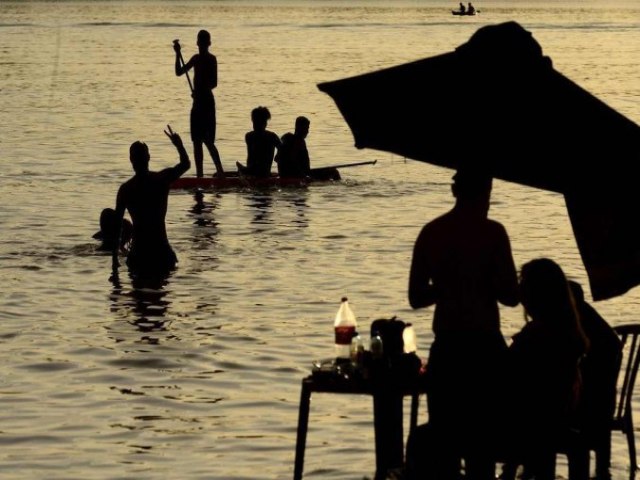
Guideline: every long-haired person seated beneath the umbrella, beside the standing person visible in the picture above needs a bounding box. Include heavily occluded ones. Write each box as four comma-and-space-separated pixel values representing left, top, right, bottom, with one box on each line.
497, 258, 589, 480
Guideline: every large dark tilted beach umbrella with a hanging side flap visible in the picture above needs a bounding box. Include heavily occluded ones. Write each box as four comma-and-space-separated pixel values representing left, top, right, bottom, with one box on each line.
318, 22, 640, 300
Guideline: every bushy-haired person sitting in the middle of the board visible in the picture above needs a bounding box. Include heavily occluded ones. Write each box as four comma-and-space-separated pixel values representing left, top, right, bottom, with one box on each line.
238, 107, 281, 178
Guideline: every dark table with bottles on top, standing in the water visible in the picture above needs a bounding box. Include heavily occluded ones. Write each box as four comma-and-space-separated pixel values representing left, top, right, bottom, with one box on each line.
293, 368, 426, 480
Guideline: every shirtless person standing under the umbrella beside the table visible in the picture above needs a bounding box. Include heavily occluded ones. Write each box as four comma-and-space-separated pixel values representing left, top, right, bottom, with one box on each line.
409, 168, 518, 480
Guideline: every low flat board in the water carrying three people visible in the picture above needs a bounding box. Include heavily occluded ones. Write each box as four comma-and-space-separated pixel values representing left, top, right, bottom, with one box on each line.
170, 160, 377, 190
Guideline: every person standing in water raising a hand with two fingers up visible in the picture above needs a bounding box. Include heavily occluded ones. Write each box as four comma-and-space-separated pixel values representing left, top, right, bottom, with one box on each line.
112, 126, 191, 277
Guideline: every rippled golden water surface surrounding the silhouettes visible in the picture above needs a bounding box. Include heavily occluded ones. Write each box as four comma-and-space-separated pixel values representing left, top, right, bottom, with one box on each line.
0, 0, 640, 480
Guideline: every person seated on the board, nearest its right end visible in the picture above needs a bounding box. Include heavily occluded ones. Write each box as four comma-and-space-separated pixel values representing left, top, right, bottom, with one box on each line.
275, 116, 311, 178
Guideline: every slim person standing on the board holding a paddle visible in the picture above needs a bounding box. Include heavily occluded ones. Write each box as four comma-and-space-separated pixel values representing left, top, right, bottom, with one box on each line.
173, 30, 224, 177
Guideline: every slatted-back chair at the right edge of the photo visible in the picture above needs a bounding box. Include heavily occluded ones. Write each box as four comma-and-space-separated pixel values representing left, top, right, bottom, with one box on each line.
611, 323, 640, 480
